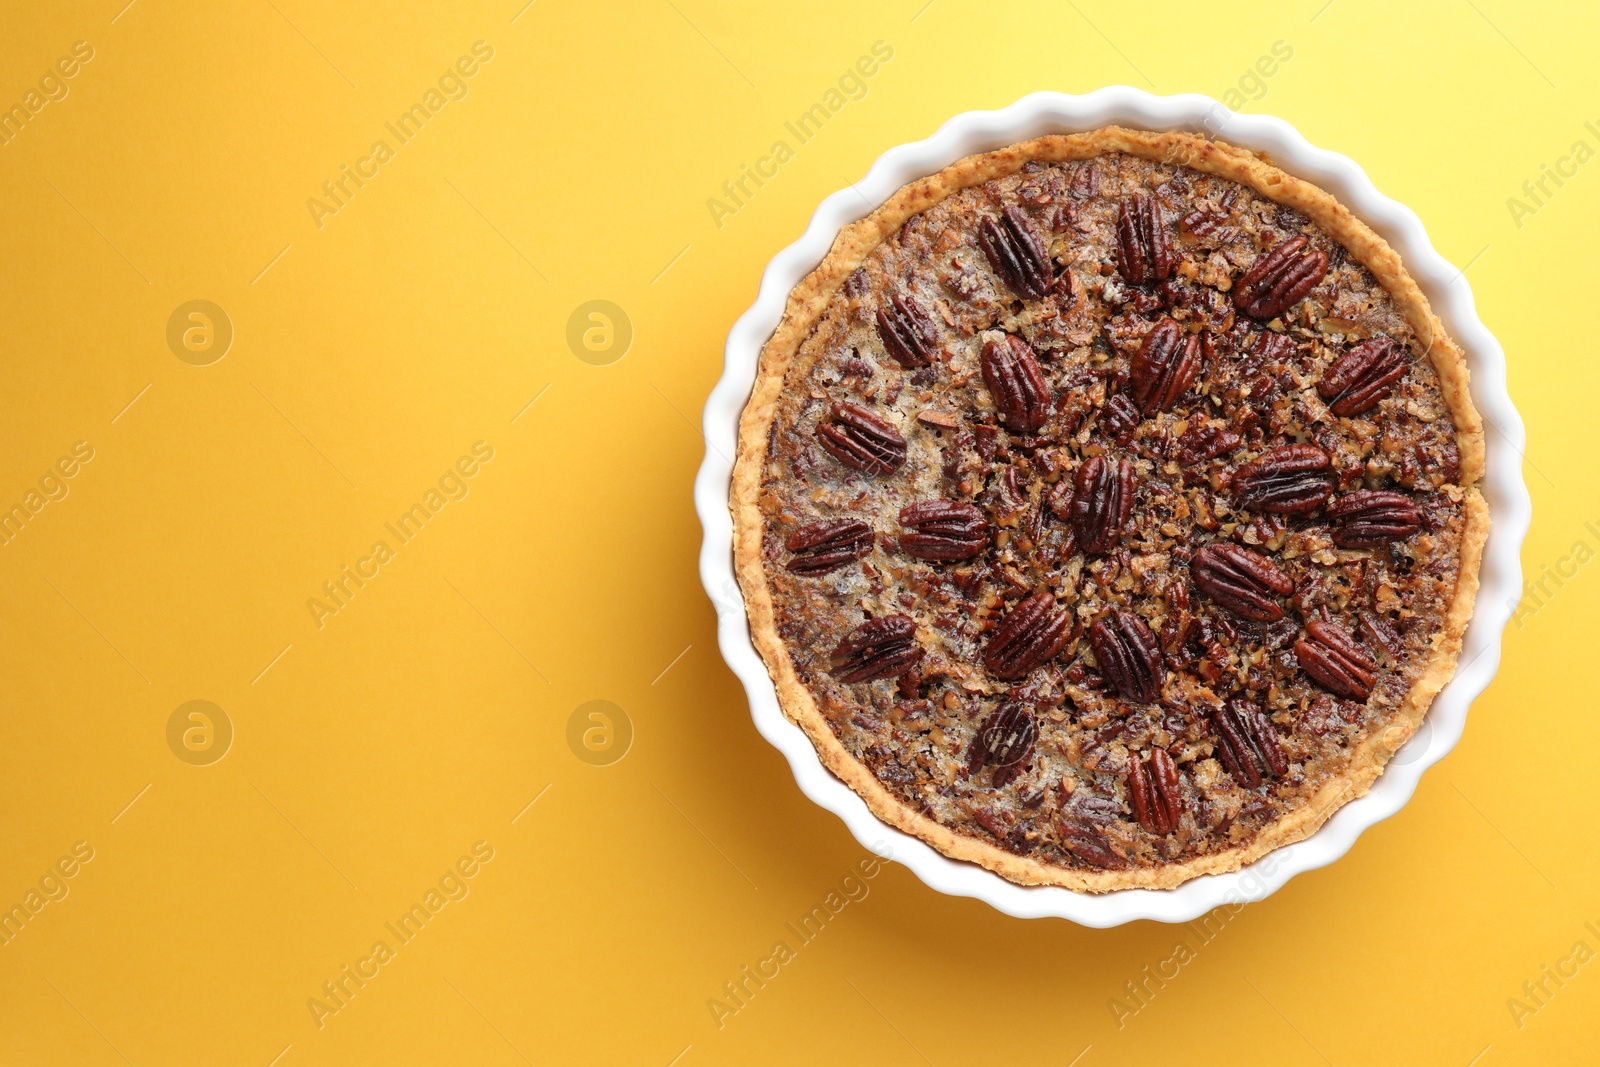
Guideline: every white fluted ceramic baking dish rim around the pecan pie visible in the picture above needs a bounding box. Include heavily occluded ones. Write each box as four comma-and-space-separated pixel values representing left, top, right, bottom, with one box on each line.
694, 86, 1531, 926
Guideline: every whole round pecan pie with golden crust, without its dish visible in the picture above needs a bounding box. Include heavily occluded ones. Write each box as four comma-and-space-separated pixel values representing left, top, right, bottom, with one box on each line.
731, 128, 1488, 893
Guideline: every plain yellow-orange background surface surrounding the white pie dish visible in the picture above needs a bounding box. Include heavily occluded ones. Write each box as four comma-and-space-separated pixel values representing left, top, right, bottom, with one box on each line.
0, 0, 1600, 1067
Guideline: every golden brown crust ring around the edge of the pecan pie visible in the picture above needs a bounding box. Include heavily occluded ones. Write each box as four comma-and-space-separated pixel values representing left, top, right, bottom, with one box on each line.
730, 126, 1490, 893
